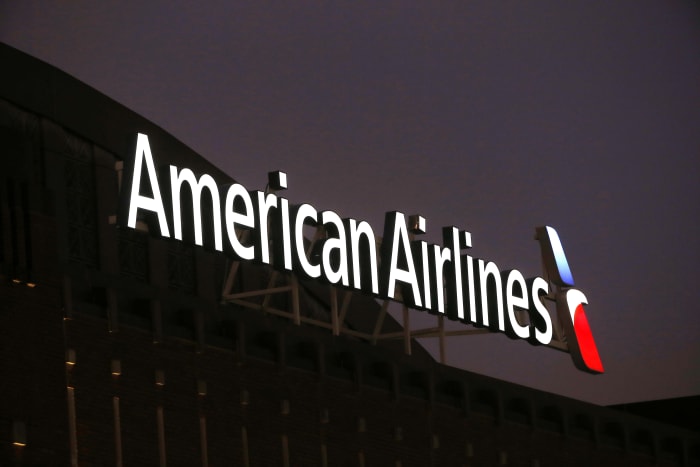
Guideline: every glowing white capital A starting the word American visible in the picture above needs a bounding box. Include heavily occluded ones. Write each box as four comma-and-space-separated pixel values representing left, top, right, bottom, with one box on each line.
126, 133, 170, 237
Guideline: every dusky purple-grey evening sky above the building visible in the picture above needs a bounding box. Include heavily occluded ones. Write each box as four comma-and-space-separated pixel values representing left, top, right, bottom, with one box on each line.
0, 0, 700, 404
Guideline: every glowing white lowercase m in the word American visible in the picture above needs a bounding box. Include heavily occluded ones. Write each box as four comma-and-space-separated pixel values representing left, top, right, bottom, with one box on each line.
170, 165, 223, 251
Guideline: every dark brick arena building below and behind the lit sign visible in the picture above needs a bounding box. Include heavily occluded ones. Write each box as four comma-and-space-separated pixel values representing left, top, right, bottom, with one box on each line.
0, 45, 700, 467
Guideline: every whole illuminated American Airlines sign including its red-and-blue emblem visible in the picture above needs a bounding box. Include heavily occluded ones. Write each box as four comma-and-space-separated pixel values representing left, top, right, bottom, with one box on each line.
118, 134, 603, 373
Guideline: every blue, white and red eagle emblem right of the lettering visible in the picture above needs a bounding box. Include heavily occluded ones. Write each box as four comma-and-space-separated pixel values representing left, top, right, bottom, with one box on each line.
537, 226, 604, 373
